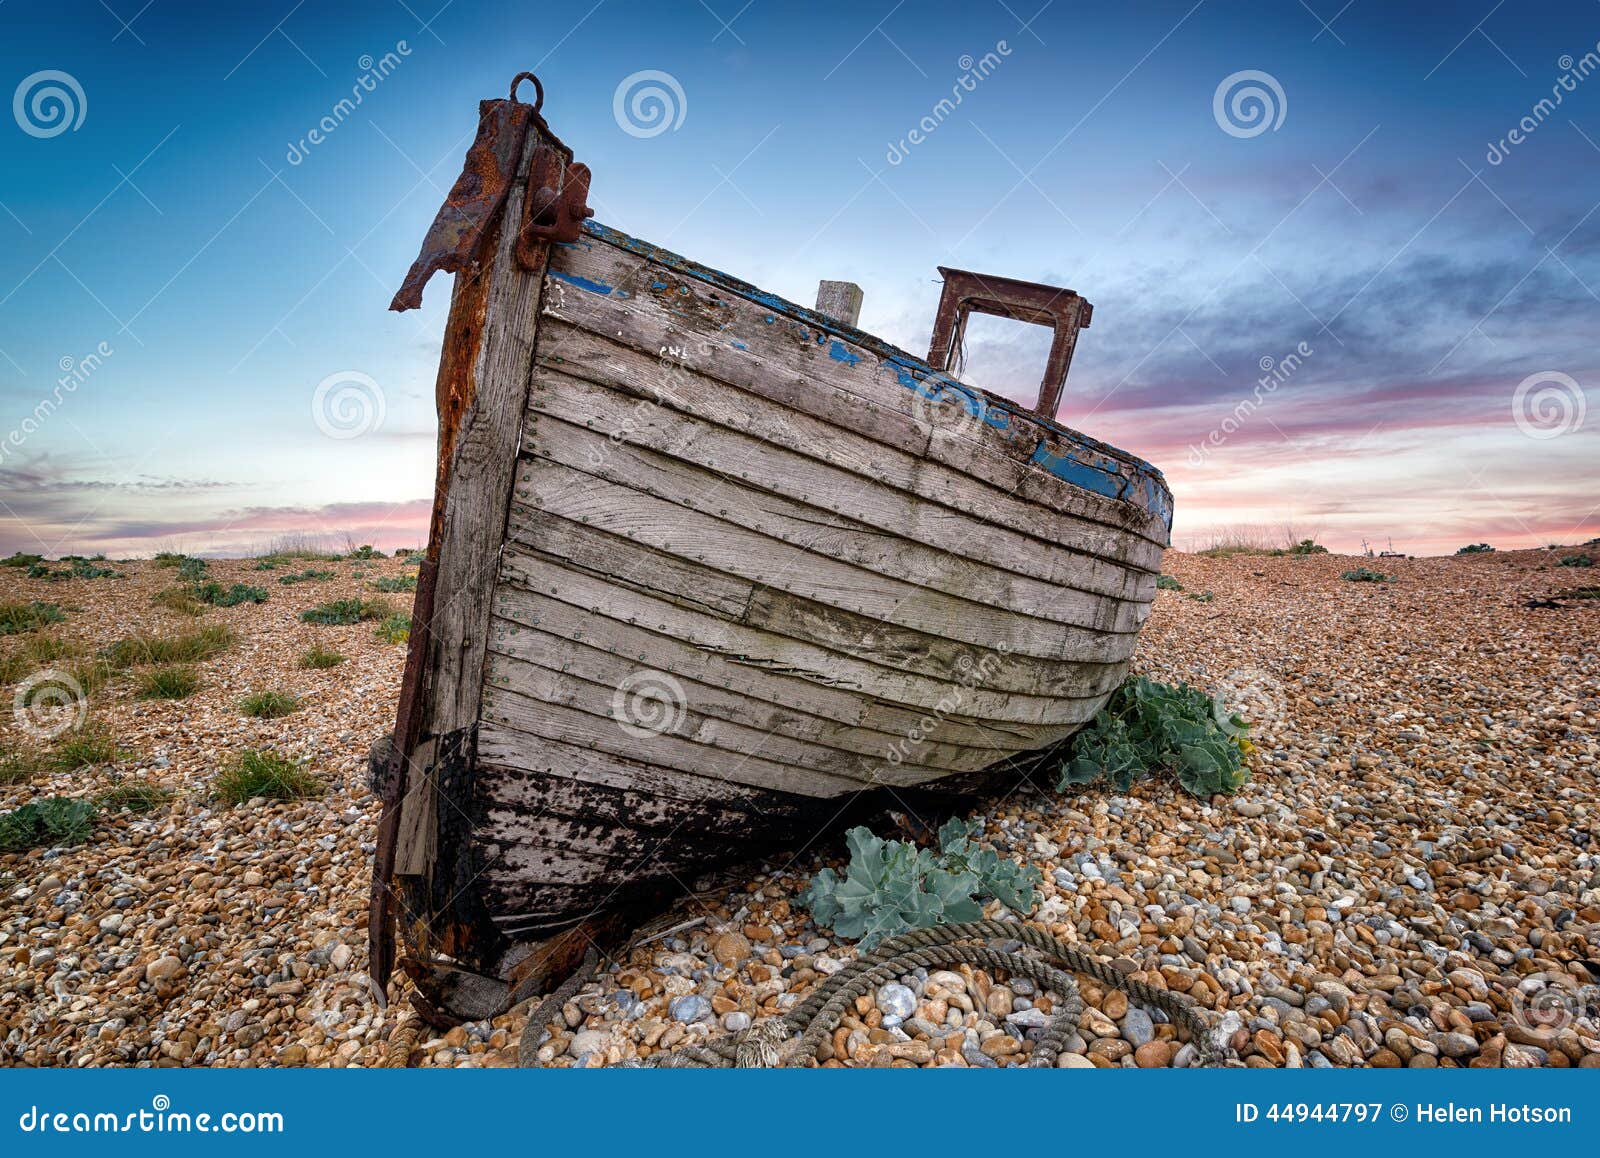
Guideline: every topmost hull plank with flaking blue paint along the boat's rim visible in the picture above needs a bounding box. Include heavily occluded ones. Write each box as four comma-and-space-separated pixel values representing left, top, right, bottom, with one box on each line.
546, 238, 1168, 547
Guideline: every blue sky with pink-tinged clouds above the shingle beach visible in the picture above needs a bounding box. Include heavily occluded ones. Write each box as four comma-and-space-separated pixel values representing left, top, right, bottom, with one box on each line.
0, 0, 1600, 557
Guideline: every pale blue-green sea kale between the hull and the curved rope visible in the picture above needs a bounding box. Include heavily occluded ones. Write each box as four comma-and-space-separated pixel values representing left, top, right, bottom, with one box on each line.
802, 819, 1040, 948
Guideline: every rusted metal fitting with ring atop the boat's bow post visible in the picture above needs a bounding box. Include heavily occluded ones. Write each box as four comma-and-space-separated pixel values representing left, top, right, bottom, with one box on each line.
389, 72, 594, 310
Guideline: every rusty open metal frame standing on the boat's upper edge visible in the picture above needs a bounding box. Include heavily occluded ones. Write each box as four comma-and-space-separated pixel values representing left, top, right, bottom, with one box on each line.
928, 266, 1094, 419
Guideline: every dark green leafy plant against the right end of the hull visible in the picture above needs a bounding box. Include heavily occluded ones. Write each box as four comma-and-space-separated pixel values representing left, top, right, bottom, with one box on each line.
1056, 677, 1253, 797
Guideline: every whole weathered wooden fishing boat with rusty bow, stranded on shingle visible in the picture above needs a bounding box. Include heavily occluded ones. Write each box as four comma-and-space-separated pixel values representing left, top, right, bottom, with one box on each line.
371, 74, 1171, 1020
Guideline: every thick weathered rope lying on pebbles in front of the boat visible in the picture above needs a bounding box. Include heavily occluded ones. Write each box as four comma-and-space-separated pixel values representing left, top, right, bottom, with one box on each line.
517, 921, 1232, 1068
